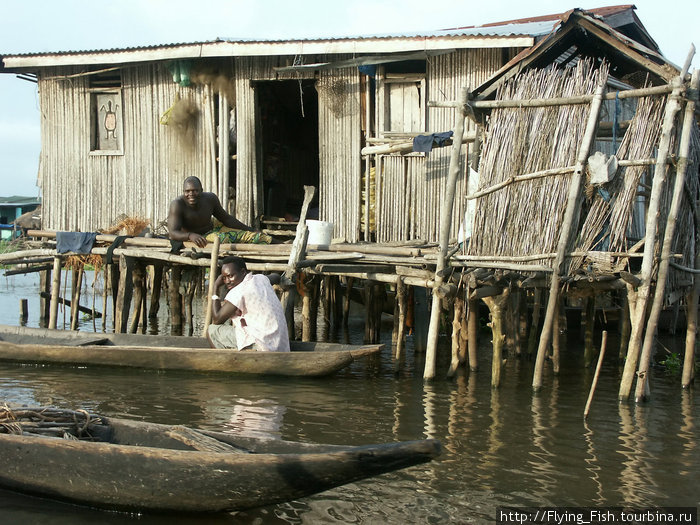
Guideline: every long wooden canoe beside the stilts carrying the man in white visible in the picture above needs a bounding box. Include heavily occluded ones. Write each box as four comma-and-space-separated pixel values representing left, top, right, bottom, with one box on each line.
0, 325, 382, 376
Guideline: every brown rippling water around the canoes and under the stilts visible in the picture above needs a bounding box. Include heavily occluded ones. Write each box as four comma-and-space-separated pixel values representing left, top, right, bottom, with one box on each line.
0, 276, 700, 525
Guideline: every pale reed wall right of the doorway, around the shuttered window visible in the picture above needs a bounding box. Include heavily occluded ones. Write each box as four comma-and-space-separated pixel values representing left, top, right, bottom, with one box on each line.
377, 49, 504, 242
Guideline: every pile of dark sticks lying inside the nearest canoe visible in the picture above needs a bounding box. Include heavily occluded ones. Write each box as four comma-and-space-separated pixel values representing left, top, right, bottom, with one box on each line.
0, 405, 102, 440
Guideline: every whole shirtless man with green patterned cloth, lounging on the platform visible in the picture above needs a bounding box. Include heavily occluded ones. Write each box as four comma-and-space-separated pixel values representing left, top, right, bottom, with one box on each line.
168, 177, 272, 248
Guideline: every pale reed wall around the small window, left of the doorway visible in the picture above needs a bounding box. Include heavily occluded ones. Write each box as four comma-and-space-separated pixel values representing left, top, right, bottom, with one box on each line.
39, 65, 218, 231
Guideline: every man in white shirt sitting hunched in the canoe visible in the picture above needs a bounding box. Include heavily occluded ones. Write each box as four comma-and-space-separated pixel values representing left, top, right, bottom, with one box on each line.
207, 257, 289, 352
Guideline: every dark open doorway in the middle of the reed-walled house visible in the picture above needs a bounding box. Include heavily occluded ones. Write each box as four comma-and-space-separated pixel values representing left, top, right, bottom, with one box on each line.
256, 80, 319, 220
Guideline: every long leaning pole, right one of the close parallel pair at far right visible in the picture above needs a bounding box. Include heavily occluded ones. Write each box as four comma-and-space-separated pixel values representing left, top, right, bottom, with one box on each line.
635, 69, 700, 402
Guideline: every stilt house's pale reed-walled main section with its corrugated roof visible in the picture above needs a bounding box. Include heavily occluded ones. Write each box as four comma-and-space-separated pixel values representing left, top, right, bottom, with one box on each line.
0, 6, 675, 241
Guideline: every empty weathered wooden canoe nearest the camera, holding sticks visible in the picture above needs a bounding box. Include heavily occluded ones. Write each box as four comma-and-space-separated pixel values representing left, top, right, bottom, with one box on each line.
0, 408, 440, 512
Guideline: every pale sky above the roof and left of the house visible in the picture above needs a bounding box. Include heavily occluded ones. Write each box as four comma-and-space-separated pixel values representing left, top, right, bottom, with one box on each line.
0, 0, 700, 197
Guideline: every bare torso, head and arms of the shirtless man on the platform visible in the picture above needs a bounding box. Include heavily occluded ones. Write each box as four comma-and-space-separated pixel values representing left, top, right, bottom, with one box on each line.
168, 177, 254, 248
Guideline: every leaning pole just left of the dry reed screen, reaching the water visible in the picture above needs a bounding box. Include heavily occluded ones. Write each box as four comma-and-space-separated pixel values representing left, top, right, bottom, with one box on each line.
423, 87, 469, 379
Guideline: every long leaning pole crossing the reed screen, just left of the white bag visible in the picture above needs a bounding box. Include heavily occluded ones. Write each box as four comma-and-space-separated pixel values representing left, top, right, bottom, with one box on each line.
532, 85, 605, 392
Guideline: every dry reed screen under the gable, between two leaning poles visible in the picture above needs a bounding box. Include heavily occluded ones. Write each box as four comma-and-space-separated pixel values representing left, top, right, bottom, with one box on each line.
469, 60, 608, 270
